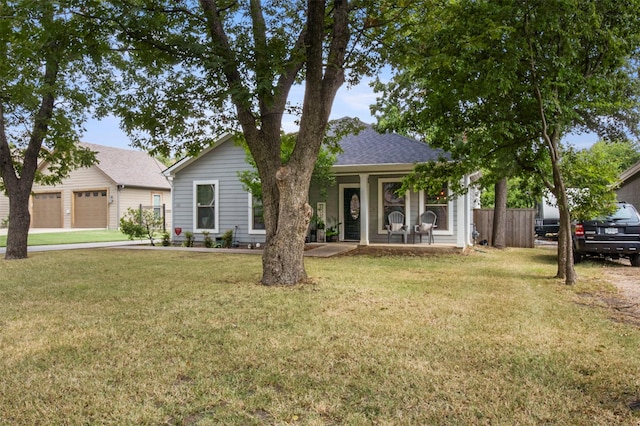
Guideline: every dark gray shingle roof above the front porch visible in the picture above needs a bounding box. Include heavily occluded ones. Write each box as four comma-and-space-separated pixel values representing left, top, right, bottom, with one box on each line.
335, 125, 443, 166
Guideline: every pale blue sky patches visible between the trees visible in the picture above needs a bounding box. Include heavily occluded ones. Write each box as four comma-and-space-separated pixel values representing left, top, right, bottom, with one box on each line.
81, 79, 598, 153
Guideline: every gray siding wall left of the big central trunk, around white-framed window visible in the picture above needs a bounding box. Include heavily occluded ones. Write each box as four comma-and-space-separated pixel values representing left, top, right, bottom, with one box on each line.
172, 141, 265, 243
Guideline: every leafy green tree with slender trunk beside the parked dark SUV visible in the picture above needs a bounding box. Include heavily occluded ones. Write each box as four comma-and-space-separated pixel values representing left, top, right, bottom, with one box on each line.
372, 0, 640, 283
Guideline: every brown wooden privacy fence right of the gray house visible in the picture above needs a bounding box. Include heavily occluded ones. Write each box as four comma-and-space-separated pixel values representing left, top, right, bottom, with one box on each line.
473, 209, 536, 248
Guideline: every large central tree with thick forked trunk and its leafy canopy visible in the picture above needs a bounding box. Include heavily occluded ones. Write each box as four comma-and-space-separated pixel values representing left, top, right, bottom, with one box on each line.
105, 0, 379, 284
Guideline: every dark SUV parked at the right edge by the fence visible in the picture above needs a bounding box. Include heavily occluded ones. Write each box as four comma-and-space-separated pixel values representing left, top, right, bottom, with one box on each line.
573, 202, 640, 266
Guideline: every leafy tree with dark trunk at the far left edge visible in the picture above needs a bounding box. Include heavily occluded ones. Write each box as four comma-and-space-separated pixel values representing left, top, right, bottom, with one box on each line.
0, 0, 118, 259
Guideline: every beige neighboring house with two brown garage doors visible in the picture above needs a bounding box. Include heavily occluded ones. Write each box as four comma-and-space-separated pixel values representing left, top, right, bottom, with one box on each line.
0, 143, 171, 229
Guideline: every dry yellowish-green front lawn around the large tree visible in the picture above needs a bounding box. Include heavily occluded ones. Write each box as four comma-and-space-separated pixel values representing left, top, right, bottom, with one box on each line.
0, 249, 640, 425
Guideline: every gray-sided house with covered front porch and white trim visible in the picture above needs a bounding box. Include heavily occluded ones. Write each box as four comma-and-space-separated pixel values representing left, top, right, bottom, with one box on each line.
164, 126, 475, 247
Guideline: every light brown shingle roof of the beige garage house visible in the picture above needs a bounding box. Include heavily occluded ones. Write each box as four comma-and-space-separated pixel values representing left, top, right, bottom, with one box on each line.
81, 143, 171, 189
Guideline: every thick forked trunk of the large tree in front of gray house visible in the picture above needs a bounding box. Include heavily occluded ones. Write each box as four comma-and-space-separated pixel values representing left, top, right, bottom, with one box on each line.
200, 0, 350, 285
